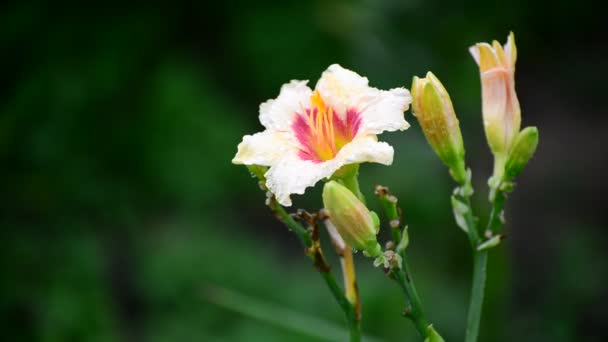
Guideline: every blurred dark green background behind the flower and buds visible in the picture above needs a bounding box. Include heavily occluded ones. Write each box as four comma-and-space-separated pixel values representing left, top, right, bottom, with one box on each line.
0, 0, 608, 342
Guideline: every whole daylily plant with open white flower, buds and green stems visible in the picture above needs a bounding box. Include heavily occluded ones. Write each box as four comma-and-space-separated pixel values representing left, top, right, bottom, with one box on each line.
232, 33, 538, 342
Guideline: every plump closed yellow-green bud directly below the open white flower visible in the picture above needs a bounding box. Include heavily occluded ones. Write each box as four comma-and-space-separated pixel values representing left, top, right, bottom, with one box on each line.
323, 181, 382, 257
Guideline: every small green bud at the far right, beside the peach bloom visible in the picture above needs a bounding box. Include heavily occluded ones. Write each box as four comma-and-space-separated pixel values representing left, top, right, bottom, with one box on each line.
504, 127, 538, 181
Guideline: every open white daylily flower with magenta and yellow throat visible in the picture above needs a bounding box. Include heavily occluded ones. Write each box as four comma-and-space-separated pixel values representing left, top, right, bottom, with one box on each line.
232, 64, 411, 206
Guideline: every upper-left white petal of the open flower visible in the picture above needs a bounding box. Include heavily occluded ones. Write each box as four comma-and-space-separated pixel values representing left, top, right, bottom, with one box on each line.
260, 80, 312, 131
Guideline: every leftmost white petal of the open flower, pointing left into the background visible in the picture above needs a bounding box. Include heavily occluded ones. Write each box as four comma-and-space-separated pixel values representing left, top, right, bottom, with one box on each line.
232, 130, 296, 166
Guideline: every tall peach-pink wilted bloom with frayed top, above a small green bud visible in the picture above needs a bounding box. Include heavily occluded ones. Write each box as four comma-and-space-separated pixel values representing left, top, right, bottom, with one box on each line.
469, 32, 521, 159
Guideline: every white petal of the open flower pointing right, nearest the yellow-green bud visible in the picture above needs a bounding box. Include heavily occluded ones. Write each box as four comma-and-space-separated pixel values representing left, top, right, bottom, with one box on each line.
358, 88, 412, 134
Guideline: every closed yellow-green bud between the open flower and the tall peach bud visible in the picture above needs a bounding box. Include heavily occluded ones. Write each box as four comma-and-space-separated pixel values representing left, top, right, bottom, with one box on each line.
412, 71, 466, 183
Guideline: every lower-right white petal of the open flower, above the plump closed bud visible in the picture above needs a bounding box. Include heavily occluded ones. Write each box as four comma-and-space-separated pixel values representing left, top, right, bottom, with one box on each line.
333, 135, 394, 166
